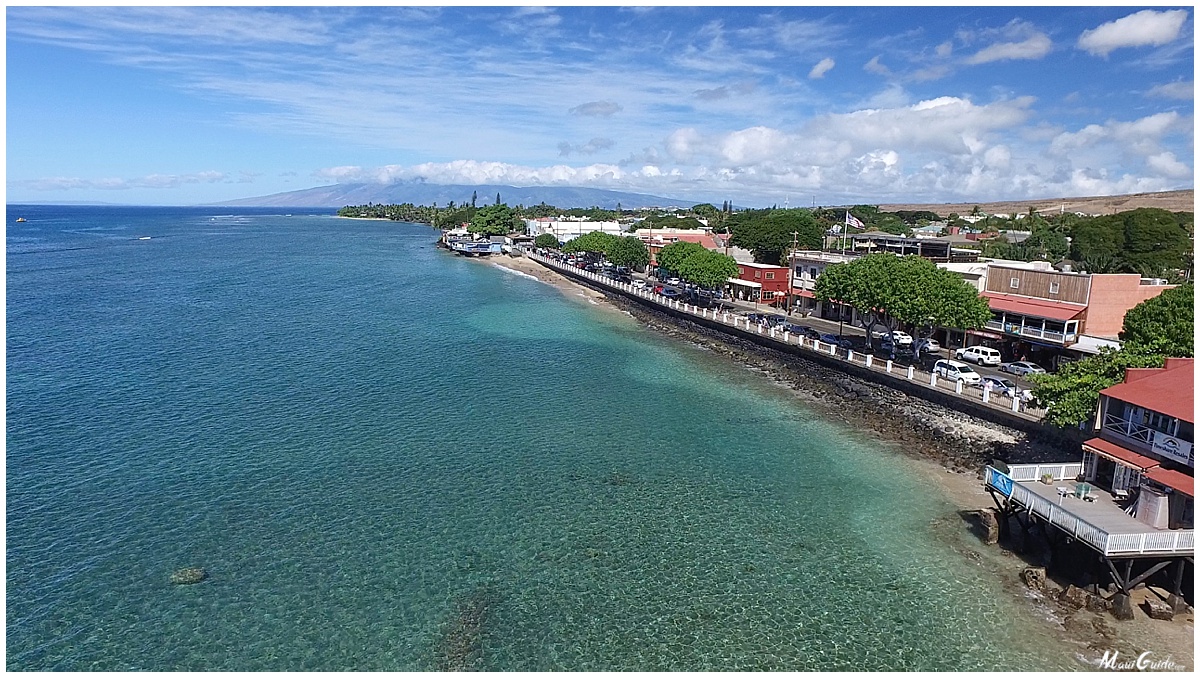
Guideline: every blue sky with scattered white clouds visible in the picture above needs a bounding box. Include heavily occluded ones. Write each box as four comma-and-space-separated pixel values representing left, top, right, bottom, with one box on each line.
6, 6, 1194, 205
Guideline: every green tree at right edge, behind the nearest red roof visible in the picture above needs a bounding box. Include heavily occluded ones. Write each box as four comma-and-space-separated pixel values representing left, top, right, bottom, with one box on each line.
1121, 283, 1195, 358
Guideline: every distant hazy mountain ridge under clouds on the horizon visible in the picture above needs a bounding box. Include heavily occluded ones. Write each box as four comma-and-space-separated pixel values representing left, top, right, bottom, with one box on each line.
217, 182, 697, 210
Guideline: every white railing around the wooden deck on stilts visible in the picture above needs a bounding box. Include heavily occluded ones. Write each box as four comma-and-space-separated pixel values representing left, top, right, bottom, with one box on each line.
984, 463, 1195, 557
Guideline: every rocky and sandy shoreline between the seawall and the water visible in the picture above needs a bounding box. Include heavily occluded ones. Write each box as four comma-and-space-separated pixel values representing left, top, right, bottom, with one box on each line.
493, 250, 1194, 671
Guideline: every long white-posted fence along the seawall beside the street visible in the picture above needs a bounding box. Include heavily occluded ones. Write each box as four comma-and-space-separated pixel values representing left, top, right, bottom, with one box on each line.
526, 251, 1045, 420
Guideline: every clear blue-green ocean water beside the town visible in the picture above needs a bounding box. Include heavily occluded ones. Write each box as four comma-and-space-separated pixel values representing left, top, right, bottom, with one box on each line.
6, 206, 1072, 671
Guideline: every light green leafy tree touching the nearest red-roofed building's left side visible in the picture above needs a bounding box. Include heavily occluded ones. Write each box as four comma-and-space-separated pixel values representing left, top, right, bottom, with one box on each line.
1030, 348, 1163, 428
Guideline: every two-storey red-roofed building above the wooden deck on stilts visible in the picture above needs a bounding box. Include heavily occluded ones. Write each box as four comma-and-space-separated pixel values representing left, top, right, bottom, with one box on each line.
1084, 358, 1195, 529
